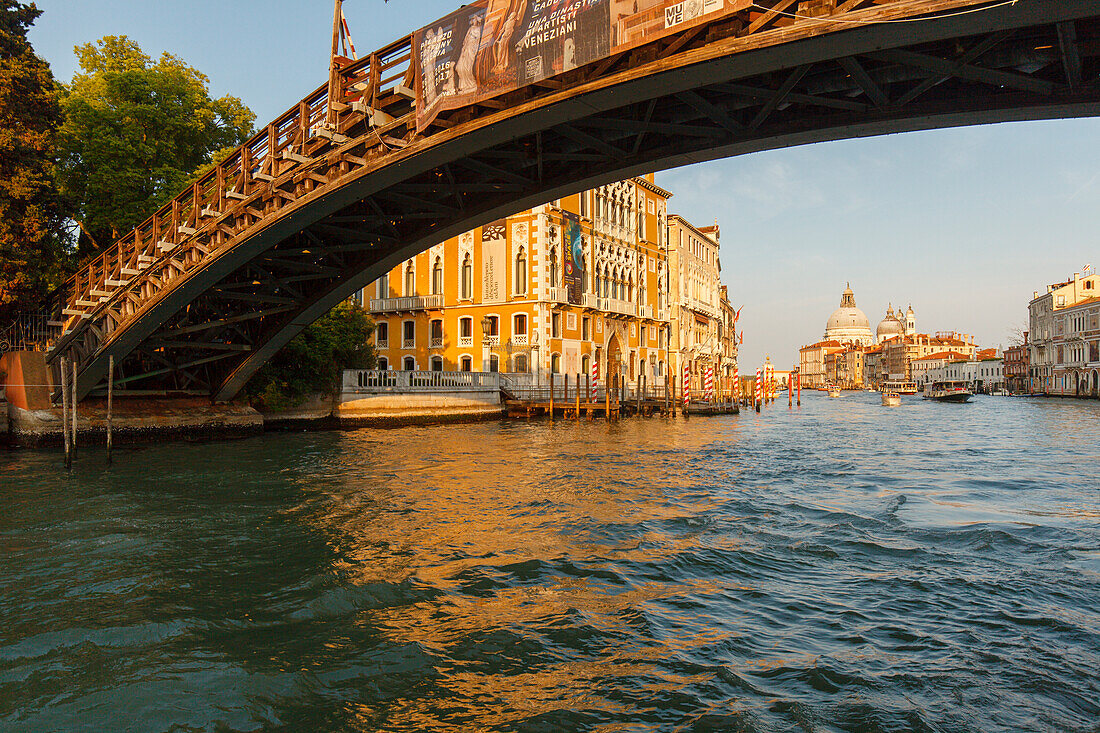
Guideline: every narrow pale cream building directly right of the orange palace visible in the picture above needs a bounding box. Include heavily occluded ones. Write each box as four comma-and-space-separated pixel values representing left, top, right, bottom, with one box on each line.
668, 214, 736, 385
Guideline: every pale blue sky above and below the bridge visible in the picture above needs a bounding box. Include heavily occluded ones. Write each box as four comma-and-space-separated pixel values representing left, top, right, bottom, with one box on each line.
31, 0, 1100, 371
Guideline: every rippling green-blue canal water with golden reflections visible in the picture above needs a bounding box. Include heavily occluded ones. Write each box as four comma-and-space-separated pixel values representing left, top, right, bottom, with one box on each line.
0, 393, 1100, 733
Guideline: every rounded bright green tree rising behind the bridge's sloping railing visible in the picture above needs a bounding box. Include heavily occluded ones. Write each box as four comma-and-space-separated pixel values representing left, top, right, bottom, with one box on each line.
61, 35, 255, 250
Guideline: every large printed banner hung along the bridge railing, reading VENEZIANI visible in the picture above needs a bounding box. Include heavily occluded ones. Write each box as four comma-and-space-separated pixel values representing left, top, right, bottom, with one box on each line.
413, 0, 751, 131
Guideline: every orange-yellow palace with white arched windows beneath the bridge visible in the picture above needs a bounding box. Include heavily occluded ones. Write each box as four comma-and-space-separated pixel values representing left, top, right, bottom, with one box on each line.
361, 175, 668, 384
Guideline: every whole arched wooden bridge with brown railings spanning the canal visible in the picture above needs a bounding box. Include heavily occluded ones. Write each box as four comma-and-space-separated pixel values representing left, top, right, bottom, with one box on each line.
34, 0, 1100, 400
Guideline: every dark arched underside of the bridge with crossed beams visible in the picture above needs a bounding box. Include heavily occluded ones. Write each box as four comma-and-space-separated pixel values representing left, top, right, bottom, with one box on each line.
51, 0, 1100, 400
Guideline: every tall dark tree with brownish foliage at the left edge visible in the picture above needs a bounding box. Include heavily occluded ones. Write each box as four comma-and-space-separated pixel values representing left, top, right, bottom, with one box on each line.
0, 0, 66, 326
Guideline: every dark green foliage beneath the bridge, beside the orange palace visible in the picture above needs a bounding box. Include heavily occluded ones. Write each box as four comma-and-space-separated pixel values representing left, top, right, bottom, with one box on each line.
248, 302, 376, 409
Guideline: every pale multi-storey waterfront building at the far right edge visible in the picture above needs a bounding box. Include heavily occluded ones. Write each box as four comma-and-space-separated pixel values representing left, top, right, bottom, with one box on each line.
1027, 267, 1100, 396
